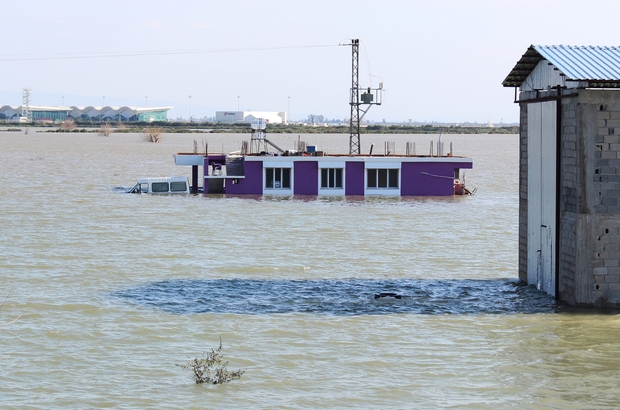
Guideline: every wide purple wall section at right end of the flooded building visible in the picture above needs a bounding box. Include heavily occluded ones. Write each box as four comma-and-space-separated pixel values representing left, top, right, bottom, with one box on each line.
400, 162, 471, 196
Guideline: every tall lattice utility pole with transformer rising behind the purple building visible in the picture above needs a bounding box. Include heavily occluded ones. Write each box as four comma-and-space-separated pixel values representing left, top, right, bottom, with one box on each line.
344, 39, 383, 155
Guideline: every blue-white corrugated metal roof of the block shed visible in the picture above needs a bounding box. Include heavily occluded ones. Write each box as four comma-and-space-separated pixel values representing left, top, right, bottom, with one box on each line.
502, 45, 620, 87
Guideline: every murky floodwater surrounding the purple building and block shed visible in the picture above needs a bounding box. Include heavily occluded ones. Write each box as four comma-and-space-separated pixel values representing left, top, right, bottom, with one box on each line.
0, 128, 620, 409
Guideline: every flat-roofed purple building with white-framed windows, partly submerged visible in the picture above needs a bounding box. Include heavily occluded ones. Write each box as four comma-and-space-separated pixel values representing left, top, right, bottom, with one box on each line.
175, 150, 473, 196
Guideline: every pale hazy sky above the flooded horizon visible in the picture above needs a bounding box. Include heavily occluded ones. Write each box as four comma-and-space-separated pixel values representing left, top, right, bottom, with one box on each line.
0, 0, 620, 124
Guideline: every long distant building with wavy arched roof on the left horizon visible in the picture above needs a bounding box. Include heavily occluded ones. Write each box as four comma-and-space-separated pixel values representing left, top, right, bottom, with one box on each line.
0, 105, 172, 122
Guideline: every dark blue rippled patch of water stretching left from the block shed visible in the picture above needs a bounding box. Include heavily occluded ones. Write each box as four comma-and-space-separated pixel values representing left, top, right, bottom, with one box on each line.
112, 279, 556, 316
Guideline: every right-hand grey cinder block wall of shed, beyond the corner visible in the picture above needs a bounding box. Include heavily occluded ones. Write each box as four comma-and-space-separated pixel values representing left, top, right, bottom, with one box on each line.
575, 90, 620, 307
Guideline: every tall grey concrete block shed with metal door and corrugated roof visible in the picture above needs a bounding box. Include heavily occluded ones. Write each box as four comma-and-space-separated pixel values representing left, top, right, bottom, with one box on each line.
503, 46, 620, 307
